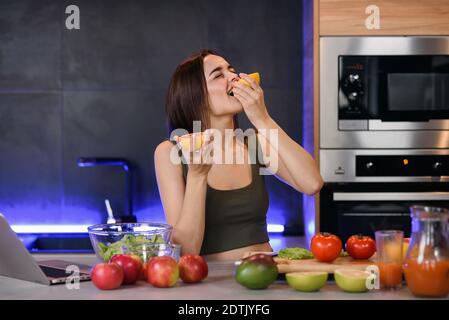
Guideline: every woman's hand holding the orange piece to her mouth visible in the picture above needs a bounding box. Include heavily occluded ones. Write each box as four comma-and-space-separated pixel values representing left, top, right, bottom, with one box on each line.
232, 73, 269, 128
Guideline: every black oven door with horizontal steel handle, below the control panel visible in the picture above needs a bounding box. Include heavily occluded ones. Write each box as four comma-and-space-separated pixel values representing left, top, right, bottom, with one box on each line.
320, 182, 449, 241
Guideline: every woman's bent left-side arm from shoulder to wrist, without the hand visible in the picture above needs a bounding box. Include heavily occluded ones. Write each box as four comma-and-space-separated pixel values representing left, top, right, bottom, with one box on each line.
154, 141, 210, 254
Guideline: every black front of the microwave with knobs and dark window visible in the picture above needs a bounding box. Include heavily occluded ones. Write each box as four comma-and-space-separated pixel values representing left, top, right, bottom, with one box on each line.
338, 55, 449, 122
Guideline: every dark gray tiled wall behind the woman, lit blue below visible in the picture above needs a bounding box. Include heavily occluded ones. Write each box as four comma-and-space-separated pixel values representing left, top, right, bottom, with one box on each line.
0, 0, 302, 231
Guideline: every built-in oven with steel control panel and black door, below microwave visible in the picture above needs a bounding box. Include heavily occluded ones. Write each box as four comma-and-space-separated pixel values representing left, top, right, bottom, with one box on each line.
319, 149, 449, 240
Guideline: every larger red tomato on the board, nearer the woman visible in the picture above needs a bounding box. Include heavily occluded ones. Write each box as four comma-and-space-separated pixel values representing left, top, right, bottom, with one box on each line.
310, 232, 342, 262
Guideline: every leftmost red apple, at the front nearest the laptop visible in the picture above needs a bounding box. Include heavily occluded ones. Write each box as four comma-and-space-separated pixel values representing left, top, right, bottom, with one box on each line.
91, 263, 124, 290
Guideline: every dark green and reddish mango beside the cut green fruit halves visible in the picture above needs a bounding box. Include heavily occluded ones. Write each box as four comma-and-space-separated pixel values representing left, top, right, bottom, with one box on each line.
235, 254, 278, 289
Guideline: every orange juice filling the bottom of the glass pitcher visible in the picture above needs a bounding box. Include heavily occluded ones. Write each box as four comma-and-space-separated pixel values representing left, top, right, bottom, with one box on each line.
404, 259, 449, 297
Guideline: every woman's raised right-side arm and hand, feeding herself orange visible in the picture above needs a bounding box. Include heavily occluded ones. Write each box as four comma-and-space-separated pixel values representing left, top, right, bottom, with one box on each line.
233, 74, 323, 195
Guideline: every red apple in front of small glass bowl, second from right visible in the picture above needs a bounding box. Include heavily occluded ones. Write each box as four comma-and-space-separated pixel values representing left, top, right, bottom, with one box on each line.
147, 256, 179, 288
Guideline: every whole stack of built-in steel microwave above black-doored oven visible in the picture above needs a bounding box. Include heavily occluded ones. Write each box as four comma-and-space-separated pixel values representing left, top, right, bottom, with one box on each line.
319, 37, 449, 240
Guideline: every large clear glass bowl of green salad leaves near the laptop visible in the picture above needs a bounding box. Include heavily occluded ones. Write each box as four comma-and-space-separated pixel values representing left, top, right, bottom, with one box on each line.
87, 222, 173, 261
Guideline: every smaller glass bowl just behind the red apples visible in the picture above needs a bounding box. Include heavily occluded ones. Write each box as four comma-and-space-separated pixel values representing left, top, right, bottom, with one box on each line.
122, 243, 181, 263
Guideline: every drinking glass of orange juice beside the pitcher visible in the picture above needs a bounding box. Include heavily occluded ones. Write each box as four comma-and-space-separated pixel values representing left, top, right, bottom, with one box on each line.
375, 230, 404, 289
